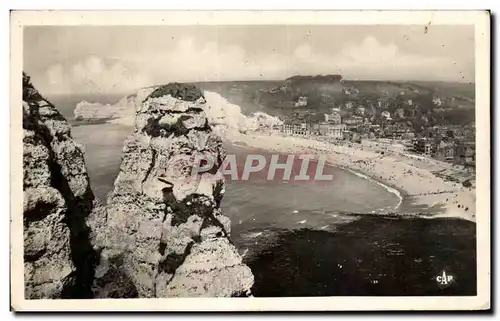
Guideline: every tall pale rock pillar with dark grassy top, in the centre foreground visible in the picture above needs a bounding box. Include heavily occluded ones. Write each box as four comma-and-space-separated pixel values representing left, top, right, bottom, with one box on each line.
94, 83, 254, 298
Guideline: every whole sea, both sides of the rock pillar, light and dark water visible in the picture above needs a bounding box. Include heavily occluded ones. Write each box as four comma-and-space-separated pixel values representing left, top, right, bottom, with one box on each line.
49, 92, 476, 297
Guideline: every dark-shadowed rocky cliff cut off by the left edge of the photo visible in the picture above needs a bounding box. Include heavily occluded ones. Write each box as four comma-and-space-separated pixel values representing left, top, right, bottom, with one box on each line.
23, 73, 98, 299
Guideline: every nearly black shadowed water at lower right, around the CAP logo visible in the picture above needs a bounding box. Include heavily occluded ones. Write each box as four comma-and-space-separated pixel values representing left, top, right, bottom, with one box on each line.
244, 215, 476, 297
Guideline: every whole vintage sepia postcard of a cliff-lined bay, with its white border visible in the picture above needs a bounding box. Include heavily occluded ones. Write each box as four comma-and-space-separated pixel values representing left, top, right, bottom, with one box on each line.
10, 11, 491, 311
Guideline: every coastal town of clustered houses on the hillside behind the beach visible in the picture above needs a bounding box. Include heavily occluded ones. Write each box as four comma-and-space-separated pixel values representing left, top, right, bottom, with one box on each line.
259, 80, 475, 167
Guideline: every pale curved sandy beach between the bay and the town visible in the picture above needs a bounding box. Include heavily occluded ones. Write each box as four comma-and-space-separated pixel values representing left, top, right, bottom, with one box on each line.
226, 132, 476, 222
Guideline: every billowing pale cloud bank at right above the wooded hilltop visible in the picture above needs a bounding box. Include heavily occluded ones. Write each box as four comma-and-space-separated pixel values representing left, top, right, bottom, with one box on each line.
291, 37, 474, 81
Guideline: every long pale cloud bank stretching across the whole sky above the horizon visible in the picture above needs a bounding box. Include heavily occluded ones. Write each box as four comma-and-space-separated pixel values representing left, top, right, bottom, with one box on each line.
33, 36, 474, 94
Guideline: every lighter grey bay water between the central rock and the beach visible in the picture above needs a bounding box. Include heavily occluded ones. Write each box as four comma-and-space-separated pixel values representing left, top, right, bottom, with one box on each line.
221, 146, 399, 238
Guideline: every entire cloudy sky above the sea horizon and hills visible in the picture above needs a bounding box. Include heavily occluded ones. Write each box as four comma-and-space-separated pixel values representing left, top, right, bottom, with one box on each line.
23, 25, 474, 95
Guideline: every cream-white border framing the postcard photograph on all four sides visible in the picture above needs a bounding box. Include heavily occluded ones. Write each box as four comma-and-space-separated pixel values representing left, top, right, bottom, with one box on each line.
10, 11, 491, 311
